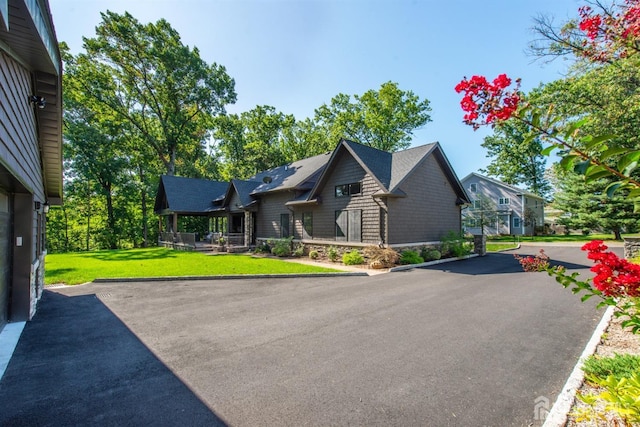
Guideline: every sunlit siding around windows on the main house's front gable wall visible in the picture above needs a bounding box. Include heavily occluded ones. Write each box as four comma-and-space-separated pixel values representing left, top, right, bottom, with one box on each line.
296, 154, 380, 244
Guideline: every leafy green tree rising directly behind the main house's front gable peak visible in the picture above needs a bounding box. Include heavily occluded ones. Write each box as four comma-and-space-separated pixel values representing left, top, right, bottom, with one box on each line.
314, 82, 431, 152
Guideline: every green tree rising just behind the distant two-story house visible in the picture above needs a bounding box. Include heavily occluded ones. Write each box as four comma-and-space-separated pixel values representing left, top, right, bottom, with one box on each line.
482, 121, 551, 197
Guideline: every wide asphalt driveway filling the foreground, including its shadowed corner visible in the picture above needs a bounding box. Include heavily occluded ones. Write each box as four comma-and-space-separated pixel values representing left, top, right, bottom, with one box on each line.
0, 247, 602, 426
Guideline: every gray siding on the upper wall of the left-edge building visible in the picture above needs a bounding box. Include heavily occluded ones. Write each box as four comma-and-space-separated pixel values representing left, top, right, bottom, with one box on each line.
0, 51, 45, 201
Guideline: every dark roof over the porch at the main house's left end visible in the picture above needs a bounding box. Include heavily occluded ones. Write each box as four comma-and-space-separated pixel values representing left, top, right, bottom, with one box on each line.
154, 175, 229, 214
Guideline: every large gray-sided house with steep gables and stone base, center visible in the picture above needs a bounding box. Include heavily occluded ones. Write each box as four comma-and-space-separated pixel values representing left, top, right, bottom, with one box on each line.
156, 140, 469, 251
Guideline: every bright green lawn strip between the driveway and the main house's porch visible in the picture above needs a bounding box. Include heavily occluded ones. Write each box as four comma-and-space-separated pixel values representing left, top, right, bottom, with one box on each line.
45, 248, 338, 285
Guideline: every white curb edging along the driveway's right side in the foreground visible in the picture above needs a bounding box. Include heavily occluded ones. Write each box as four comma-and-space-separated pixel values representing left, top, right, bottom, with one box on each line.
542, 306, 615, 427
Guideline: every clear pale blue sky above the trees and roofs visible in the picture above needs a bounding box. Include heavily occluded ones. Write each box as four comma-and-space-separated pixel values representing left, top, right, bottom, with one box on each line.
49, 0, 583, 178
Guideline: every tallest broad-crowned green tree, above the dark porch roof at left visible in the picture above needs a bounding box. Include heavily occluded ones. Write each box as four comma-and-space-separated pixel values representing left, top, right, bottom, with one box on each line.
66, 11, 236, 175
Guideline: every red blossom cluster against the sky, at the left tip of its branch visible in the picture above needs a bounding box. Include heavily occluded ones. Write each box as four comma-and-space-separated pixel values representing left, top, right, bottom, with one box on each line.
455, 74, 520, 130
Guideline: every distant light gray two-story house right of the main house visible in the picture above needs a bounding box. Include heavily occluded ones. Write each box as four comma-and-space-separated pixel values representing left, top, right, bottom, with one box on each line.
462, 173, 544, 236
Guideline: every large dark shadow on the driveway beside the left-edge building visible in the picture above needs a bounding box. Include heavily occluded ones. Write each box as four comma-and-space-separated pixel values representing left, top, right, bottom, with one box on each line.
0, 291, 226, 426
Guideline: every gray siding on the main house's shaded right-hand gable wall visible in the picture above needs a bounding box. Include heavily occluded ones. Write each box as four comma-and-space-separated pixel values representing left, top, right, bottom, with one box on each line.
388, 156, 460, 244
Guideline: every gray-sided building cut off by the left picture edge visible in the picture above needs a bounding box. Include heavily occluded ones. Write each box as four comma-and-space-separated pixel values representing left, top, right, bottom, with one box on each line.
0, 0, 62, 330
